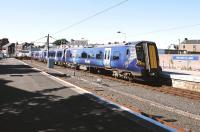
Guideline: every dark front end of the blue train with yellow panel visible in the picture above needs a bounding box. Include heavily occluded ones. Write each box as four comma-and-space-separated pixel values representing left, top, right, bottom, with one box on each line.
135, 42, 161, 78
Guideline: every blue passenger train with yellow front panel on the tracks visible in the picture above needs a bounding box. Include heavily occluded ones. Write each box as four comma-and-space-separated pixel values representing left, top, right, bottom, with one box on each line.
32, 41, 162, 80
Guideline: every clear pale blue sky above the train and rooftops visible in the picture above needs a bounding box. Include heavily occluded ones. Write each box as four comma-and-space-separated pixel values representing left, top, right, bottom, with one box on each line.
0, 0, 200, 48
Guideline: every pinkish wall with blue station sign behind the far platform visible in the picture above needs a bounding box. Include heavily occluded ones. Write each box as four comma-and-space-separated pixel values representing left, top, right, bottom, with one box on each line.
159, 54, 200, 71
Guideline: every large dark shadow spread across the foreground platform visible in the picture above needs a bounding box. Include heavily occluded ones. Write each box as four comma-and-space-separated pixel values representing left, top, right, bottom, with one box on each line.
0, 79, 153, 132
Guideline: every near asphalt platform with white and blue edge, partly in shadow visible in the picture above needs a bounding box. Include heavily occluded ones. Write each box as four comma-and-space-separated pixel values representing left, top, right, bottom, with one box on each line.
0, 58, 176, 132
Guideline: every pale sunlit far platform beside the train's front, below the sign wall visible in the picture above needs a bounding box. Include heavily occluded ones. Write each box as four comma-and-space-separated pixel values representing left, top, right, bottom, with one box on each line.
161, 69, 200, 92
